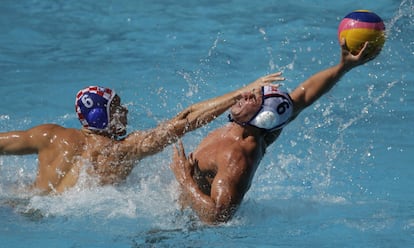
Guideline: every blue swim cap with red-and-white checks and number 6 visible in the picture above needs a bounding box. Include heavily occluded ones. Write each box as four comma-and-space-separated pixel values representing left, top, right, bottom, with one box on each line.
75, 86, 116, 130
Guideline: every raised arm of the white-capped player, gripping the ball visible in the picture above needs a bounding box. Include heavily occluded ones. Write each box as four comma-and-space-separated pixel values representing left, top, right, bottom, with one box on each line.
290, 41, 380, 117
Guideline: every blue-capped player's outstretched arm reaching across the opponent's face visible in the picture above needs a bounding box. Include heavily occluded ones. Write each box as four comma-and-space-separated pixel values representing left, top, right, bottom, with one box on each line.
132, 72, 284, 158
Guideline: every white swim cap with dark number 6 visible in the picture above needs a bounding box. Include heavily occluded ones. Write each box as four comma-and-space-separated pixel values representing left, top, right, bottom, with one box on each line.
247, 85, 293, 132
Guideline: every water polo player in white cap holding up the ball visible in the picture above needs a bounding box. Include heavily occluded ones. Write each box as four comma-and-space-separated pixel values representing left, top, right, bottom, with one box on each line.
171, 39, 374, 224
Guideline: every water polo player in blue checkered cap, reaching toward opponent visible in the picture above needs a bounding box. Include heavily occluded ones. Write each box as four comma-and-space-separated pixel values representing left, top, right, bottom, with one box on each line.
0, 73, 281, 193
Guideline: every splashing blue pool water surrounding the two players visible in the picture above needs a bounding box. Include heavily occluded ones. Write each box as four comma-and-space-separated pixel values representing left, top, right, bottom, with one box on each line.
0, 0, 414, 248
